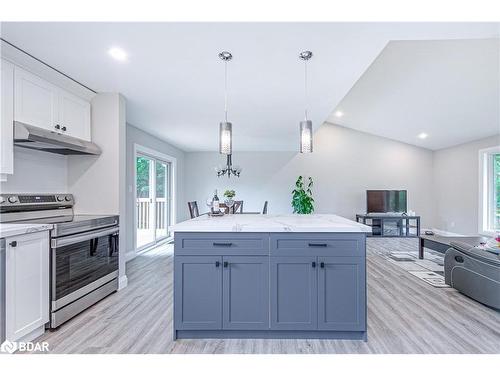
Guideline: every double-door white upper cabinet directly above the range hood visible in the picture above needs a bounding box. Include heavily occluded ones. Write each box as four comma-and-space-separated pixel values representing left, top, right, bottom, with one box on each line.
14, 67, 91, 141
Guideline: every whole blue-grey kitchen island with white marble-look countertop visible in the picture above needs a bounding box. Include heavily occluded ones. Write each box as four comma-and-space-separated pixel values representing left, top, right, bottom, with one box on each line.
170, 214, 371, 340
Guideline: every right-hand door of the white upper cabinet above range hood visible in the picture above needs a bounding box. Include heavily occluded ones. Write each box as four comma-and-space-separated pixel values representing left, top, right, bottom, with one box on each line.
58, 90, 90, 141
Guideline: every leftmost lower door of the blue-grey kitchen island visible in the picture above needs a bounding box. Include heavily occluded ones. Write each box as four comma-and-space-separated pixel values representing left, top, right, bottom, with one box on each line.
174, 256, 222, 330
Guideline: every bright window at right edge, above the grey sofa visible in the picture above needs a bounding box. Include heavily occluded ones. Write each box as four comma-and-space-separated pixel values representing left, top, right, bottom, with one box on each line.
479, 147, 500, 234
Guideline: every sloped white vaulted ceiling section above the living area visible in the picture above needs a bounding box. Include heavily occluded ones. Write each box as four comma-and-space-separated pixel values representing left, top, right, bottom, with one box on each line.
328, 39, 500, 150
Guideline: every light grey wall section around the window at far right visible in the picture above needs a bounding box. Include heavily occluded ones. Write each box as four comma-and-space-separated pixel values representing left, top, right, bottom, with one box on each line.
433, 136, 500, 234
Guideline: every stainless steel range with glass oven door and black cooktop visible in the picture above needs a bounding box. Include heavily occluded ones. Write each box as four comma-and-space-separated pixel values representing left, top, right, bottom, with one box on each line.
0, 194, 119, 328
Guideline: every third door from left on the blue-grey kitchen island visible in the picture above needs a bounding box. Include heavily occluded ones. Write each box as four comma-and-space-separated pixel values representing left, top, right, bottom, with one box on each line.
270, 256, 317, 330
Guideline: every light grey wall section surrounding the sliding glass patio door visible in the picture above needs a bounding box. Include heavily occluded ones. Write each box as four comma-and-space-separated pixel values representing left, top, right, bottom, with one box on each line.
125, 124, 187, 258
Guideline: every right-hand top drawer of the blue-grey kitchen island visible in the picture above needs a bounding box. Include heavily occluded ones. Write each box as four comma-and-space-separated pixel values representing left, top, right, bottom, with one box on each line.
271, 233, 365, 256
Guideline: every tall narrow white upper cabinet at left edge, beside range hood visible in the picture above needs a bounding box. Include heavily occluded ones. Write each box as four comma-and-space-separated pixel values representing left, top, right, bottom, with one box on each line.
0, 60, 14, 181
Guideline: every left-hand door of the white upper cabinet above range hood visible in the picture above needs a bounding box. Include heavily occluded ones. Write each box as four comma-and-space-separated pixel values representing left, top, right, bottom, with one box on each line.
14, 67, 58, 130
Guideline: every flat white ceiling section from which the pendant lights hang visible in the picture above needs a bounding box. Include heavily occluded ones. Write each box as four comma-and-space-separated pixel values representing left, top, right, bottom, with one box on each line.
2, 23, 498, 151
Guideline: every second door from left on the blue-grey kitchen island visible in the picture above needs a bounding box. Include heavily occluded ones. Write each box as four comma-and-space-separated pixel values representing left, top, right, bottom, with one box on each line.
222, 256, 269, 330
